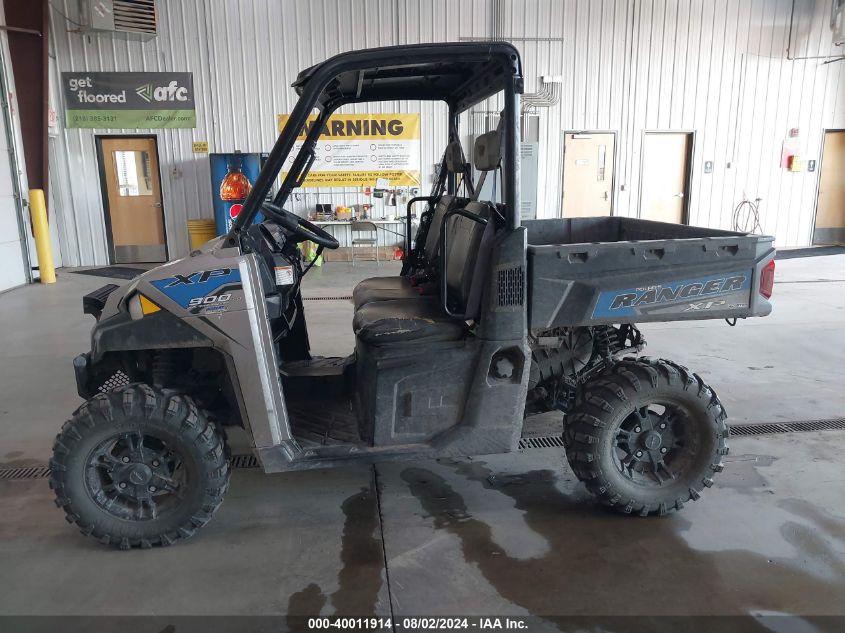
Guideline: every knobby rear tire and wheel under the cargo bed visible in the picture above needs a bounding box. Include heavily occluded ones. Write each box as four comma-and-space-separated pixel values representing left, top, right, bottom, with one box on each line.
564, 358, 728, 516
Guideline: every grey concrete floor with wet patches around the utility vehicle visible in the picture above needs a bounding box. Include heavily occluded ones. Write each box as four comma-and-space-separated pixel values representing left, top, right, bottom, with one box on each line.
0, 255, 845, 620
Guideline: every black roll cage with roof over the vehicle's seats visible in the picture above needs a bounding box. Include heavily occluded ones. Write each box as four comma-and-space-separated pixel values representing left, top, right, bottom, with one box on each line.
227, 42, 523, 241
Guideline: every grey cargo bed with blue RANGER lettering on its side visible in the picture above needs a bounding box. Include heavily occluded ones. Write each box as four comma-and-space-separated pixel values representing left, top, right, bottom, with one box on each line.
524, 218, 775, 330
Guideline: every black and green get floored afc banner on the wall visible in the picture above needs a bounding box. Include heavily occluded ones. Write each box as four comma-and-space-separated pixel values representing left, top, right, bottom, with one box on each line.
62, 72, 197, 129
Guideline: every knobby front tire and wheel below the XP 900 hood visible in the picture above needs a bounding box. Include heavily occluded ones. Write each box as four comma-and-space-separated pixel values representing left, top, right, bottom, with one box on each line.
50, 384, 230, 549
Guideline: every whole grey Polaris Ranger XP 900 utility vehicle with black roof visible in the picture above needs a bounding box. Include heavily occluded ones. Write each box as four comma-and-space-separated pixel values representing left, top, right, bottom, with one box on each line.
50, 42, 774, 549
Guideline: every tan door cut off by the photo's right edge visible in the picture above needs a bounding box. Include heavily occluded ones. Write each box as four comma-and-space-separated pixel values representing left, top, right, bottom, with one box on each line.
813, 131, 845, 244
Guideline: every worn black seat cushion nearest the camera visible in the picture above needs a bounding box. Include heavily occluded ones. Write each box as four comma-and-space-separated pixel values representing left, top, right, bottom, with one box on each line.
352, 297, 467, 345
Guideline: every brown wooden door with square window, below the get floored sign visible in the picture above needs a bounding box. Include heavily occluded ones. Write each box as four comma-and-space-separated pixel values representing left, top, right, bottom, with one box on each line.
100, 138, 167, 264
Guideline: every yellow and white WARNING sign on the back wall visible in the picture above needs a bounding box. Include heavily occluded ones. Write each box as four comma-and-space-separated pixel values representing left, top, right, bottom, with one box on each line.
278, 114, 420, 187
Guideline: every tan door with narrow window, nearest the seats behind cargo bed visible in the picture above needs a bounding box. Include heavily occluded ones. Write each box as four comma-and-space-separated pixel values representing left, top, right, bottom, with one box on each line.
563, 132, 616, 218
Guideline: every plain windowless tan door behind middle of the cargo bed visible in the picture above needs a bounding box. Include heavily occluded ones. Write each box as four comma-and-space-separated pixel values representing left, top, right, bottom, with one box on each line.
640, 132, 692, 224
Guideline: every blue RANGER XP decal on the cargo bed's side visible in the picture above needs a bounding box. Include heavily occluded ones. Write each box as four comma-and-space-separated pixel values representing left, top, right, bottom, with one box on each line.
593, 271, 751, 318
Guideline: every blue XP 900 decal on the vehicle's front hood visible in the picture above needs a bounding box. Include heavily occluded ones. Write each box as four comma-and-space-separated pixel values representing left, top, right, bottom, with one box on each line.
150, 268, 241, 314
